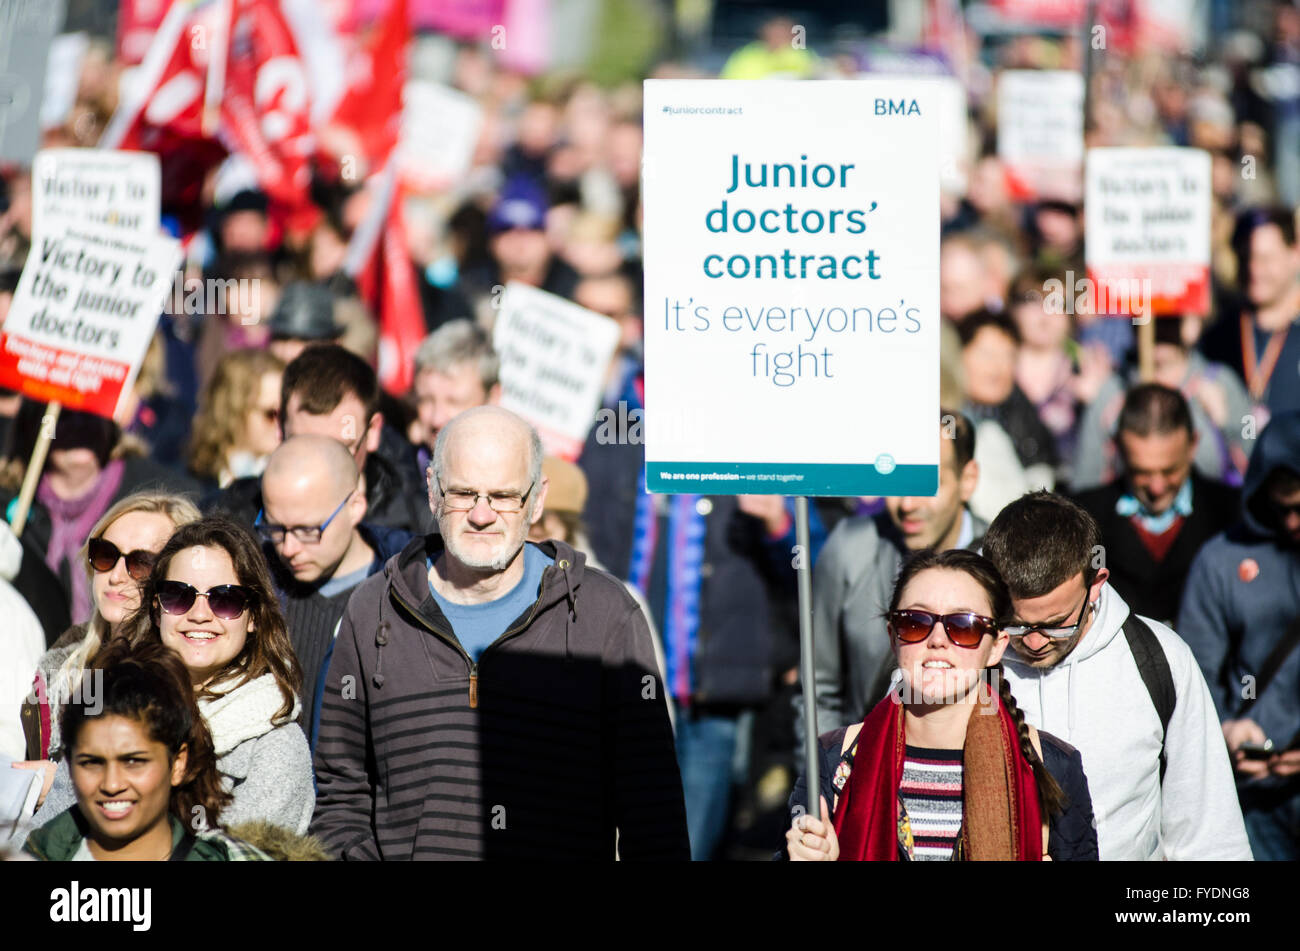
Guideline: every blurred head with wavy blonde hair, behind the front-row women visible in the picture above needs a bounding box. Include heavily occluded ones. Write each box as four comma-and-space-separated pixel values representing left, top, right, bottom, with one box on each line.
190, 349, 285, 490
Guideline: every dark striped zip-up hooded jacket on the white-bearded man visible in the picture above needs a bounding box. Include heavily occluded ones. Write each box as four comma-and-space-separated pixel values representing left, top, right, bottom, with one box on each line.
311, 535, 689, 860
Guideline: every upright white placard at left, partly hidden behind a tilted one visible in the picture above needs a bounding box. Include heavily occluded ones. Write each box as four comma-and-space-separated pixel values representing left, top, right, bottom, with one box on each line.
31, 148, 163, 236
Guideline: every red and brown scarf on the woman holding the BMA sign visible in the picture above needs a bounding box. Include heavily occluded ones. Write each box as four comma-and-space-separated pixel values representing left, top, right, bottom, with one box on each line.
835, 685, 1043, 861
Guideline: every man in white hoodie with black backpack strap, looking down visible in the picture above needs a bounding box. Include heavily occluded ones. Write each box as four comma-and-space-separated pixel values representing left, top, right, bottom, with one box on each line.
984, 492, 1251, 860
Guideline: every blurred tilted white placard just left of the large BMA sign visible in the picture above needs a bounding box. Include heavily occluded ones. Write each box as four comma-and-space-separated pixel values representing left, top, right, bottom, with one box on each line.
493, 282, 619, 461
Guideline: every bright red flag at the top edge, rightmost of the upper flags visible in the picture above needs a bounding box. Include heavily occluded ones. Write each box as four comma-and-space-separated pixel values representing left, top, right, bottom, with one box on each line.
333, 0, 411, 168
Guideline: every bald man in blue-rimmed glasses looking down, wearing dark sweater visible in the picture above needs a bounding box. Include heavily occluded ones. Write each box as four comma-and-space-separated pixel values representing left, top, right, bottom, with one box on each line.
254, 435, 411, 750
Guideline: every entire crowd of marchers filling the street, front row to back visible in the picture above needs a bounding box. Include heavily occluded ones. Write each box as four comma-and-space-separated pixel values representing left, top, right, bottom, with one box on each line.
0, 3, 1300, 860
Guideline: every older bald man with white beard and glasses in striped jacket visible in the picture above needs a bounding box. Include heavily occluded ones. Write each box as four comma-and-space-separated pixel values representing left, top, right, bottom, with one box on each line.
312, 407, 690, 861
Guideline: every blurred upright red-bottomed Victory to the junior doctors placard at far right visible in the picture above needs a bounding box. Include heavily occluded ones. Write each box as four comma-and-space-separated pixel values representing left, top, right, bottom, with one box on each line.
1084, 148, 1210, 316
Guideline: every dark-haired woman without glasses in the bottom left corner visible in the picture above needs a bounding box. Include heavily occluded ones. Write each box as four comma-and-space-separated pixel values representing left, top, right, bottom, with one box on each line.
25, 638, 267, 861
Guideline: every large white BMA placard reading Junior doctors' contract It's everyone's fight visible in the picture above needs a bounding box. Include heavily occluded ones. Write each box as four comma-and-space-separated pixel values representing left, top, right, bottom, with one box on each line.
644, 79, 940, 495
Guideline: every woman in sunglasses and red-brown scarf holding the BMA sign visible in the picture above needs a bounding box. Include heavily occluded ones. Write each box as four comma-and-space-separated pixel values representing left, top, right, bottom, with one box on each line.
785, 550, 1097, 861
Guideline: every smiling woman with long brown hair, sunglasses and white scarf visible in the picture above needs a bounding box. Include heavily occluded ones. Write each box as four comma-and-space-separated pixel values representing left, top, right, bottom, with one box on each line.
126, 516, 316, 834
